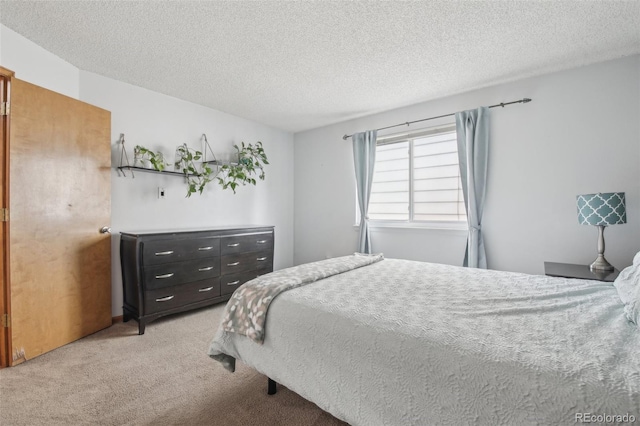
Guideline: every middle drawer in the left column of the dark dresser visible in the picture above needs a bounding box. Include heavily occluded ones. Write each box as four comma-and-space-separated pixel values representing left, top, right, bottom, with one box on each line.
144, 257, 220, 290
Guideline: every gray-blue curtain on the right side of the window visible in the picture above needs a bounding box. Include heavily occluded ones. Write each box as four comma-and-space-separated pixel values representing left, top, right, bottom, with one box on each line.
456, 107, 489, 269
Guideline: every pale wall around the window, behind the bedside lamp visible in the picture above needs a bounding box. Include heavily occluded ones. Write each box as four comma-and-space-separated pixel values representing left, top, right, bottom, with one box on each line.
294, 56, 640, 274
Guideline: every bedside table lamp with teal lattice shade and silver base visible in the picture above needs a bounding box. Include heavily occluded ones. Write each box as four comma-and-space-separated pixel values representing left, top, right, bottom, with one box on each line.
576, 192, 627, 271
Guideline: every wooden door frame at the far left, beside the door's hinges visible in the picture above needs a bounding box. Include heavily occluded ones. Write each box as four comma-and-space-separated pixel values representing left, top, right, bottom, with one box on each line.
0, 66, 15, 368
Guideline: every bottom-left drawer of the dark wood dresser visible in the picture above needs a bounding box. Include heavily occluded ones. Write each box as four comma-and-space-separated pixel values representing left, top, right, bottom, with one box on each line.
144, 278, 220, 314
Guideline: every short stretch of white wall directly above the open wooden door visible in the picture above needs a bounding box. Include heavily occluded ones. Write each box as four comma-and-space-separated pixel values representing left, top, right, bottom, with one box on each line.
0, 24, 80, 99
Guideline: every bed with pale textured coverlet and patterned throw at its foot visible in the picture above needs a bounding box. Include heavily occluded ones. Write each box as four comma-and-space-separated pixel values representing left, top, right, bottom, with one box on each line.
209, 253, 640, 426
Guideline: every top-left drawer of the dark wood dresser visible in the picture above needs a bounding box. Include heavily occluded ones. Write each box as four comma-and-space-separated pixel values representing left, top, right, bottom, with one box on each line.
142, 237, 220, 265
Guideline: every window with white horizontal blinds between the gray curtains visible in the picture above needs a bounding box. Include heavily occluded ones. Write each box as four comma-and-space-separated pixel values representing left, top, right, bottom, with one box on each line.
369, 125, 467, 223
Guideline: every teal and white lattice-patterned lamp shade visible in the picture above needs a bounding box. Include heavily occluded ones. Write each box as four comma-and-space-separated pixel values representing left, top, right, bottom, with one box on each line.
577, 192, 627, 226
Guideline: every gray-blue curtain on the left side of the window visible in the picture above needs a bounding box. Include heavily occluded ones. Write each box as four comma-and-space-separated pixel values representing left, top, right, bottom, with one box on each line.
351, 130, 378, 253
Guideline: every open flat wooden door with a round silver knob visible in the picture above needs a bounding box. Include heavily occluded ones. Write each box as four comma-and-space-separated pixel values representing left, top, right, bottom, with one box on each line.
9, 78, 111, 365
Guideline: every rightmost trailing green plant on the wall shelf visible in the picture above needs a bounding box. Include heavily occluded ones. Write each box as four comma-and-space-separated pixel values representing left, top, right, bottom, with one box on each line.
218, 141, 269, 194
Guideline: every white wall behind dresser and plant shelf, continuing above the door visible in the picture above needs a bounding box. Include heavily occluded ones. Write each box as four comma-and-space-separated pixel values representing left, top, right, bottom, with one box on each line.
0, 27, 293, 316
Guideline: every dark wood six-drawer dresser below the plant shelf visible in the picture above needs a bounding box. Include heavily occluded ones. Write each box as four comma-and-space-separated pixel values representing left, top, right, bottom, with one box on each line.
120, 226, 274, 334
